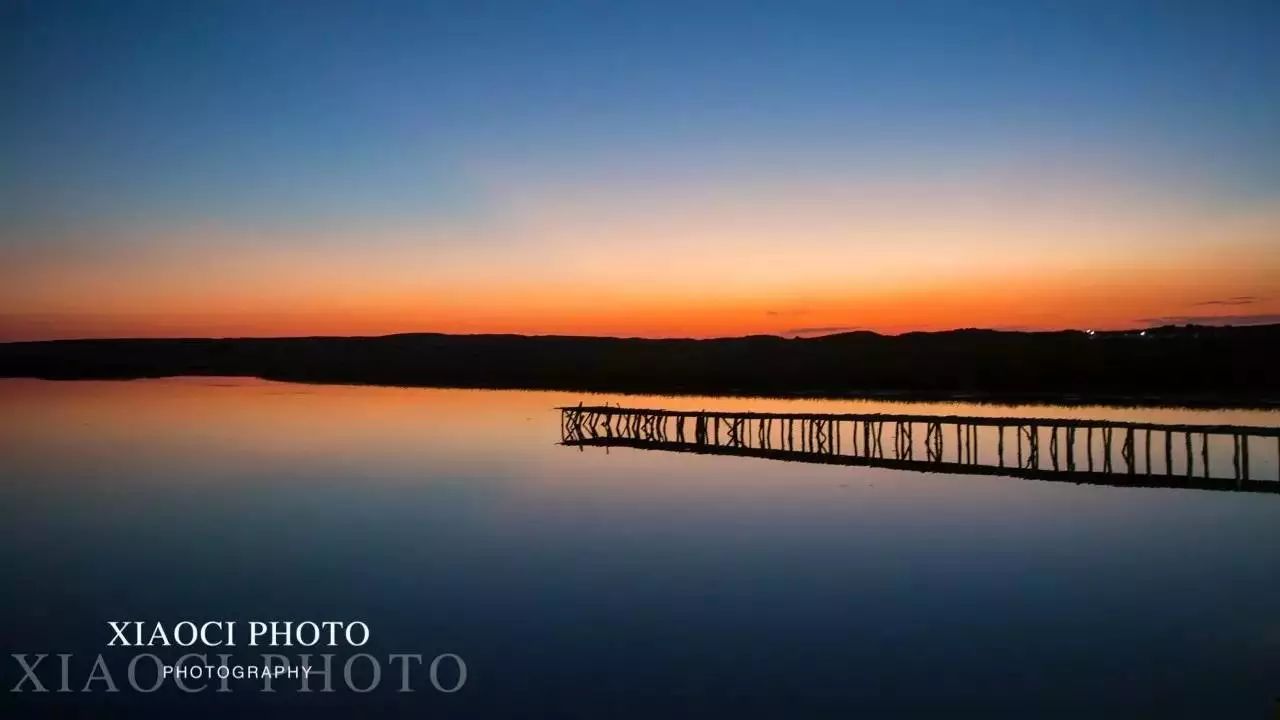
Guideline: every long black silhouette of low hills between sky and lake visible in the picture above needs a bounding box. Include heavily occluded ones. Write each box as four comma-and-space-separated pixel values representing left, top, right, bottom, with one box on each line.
0, 324, 1280, 405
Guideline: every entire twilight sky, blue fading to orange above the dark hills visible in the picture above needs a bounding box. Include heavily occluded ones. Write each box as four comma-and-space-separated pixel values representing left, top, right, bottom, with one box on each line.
0, 0, 1280, 341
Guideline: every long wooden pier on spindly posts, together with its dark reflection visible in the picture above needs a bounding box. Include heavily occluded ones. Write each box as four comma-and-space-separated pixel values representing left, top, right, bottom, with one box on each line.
559, 405, 1280, 492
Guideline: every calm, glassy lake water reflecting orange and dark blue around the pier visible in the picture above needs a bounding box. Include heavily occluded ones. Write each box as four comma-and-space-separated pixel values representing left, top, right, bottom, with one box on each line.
0, 378, 1280, 717
